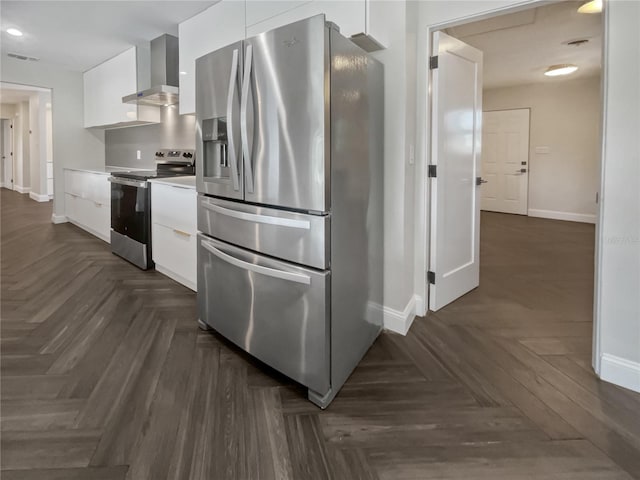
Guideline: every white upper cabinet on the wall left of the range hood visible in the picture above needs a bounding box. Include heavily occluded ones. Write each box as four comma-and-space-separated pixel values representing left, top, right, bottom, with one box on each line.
84, 47, 160, 128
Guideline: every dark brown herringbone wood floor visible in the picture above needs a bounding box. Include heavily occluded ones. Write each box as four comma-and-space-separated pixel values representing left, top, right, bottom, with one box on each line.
0, 189, 640, 480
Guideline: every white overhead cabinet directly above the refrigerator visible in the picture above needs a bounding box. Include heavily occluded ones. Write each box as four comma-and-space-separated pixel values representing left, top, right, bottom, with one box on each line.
247, 0, 368, 37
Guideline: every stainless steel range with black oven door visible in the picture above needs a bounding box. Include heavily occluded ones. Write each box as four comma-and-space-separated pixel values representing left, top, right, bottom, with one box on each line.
109, 149, 195, 270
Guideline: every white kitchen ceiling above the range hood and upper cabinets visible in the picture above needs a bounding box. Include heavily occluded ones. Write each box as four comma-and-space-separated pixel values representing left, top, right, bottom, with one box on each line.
0, 0, 217, 71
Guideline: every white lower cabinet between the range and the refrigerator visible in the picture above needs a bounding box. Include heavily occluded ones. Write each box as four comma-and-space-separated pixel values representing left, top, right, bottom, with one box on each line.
151, 182, 197, 291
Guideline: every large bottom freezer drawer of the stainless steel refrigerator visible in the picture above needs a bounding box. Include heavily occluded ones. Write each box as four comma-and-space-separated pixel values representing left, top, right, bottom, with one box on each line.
198, 234, 330, 394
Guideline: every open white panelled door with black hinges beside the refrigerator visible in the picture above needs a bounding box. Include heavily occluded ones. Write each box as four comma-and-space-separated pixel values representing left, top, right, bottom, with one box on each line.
429, 32, 482, 311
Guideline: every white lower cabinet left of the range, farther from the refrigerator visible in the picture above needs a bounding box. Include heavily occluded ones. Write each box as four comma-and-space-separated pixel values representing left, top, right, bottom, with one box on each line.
64, 170, 111, 243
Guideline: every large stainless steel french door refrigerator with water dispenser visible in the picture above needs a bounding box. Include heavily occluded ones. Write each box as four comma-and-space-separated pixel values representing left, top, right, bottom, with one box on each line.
196, 15, 383, 408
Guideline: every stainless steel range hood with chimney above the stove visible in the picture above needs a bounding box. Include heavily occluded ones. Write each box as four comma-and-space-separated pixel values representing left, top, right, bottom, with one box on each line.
122, 35, 179, 107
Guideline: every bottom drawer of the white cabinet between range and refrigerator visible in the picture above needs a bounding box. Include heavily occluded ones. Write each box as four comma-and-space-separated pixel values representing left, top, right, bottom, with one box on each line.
151, 223, 196, 290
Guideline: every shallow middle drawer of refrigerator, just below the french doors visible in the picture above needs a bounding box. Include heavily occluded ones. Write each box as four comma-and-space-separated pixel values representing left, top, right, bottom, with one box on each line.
198, 196, 330, 270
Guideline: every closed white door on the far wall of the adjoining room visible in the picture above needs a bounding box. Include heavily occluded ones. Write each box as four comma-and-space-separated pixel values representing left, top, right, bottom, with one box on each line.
480, 108, 529, 215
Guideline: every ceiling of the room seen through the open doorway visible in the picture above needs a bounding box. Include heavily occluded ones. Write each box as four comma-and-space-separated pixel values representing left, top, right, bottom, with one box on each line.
446, 1, 602, 88
